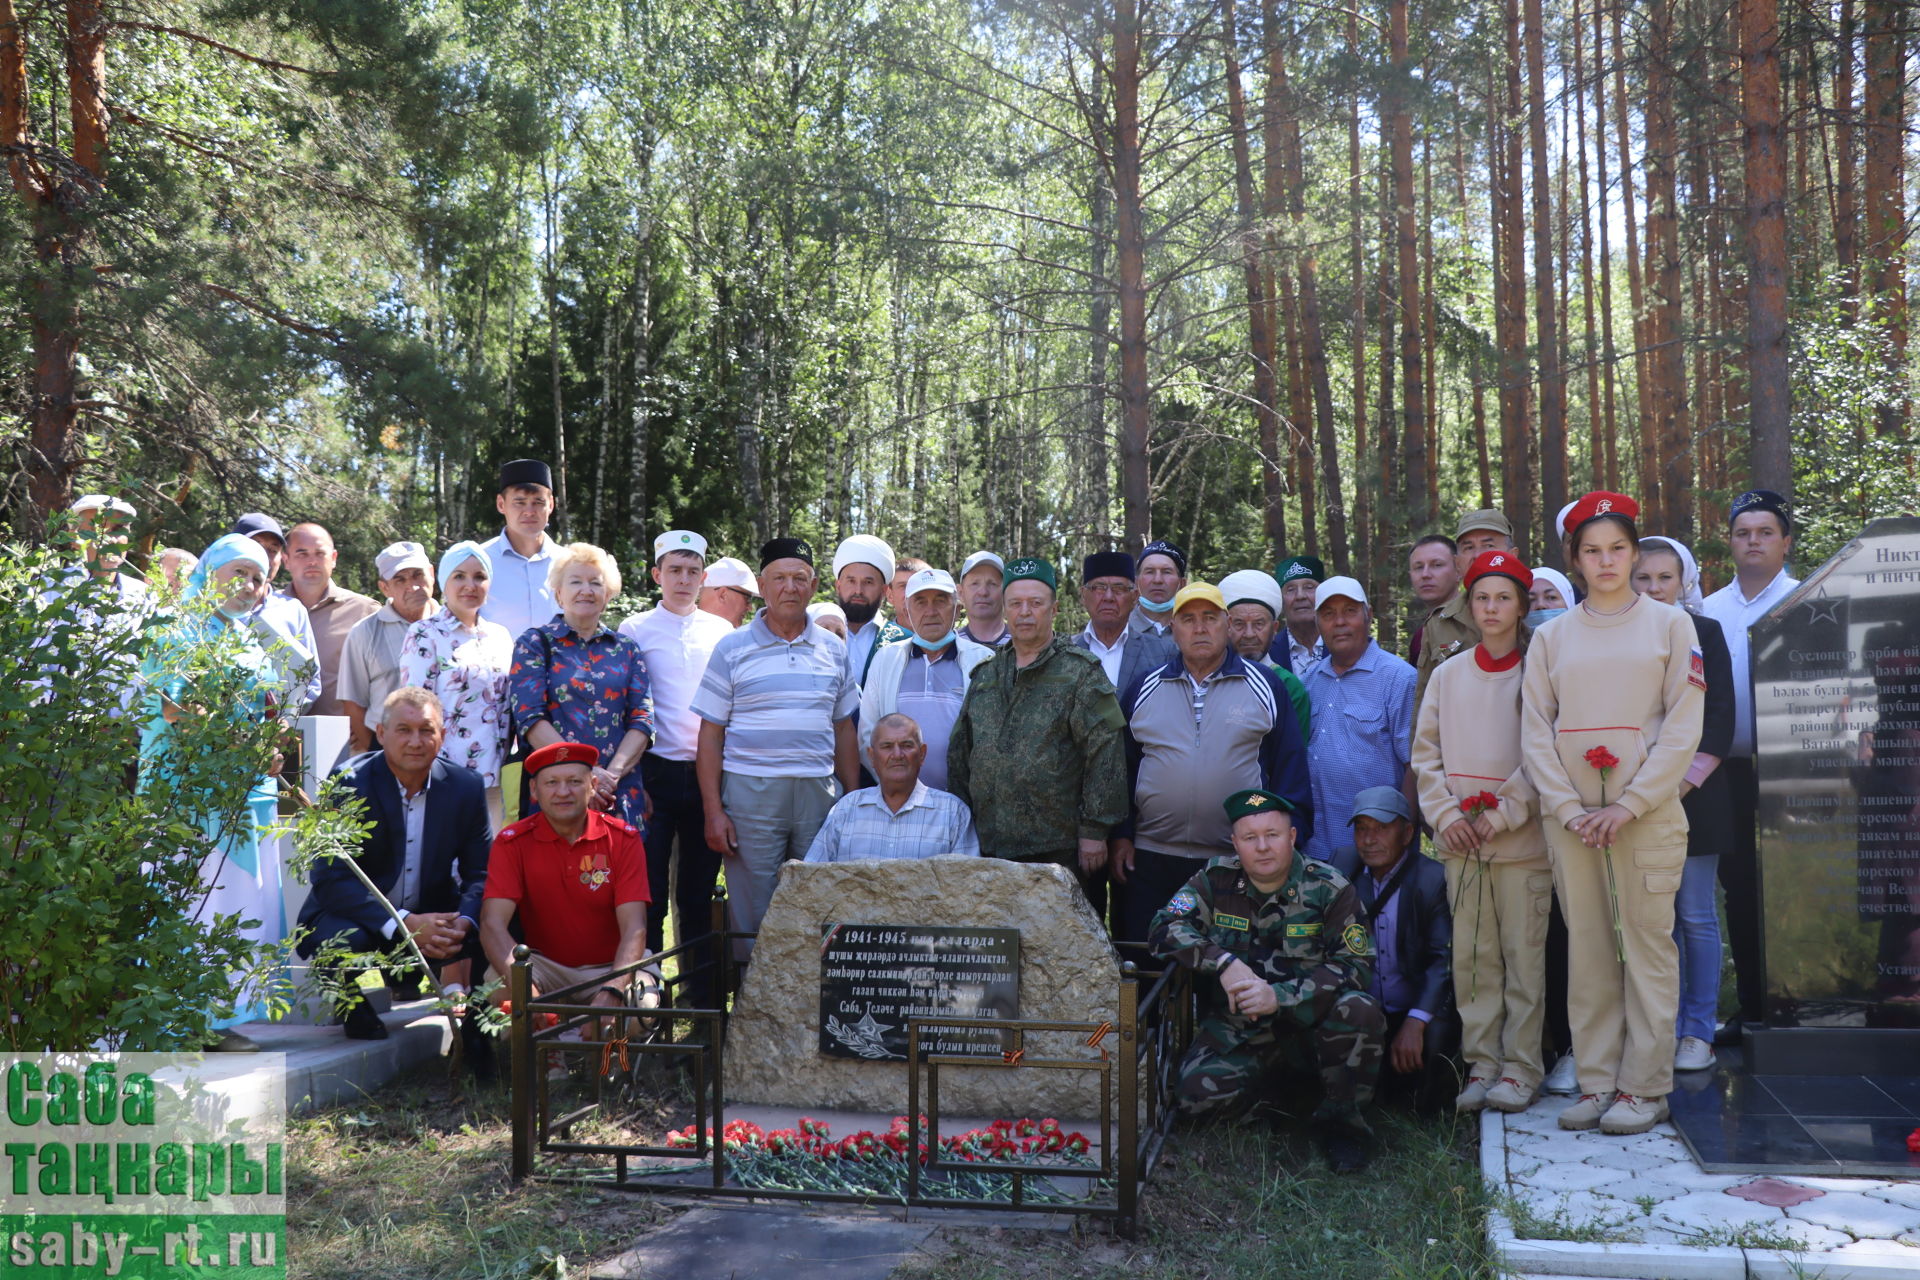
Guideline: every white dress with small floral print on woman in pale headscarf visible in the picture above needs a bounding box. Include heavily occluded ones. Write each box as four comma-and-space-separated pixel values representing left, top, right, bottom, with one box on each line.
399, 608, 513, 787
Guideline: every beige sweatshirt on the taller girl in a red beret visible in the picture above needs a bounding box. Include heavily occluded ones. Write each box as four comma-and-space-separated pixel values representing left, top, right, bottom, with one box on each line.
1523, 595, 1707, 827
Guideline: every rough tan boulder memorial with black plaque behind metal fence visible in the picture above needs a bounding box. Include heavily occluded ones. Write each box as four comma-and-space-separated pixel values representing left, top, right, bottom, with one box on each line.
726, 858, 1119, 1119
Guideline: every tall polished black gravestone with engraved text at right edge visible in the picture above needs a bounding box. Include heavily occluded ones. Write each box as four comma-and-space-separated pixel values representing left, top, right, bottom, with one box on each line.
1751, 516, 1920, 1075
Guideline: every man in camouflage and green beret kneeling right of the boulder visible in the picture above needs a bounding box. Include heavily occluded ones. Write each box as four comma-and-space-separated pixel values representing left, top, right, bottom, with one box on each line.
1152, 791, 1386, 1173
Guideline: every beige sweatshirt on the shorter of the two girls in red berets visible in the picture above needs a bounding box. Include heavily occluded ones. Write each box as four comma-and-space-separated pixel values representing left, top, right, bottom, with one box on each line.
1413, 645, 1548, 865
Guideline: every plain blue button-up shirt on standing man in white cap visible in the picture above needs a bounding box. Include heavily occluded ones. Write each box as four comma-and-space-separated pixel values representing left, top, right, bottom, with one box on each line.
1300, 639, 1415, 862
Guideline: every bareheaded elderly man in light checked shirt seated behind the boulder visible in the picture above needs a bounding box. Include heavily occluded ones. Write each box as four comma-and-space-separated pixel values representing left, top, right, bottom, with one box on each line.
806, 712, 979, 862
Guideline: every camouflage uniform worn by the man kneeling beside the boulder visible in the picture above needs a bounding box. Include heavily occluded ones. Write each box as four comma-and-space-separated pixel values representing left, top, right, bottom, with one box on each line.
1150, 854, 1386, 1128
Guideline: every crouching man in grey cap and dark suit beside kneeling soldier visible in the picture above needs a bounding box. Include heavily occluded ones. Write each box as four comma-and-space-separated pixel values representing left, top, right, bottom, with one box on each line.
1332, 787, 1461, 1109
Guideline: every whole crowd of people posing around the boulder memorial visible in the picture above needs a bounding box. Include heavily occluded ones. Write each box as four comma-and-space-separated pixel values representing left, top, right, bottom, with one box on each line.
52, 461, 1795, 1169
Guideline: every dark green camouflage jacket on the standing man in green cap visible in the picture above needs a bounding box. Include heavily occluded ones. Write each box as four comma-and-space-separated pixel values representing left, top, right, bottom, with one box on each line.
947, 637, 1129, 867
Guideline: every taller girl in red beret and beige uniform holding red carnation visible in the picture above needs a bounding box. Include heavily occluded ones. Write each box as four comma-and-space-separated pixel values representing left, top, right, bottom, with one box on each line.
1523, 493, 1707, 1134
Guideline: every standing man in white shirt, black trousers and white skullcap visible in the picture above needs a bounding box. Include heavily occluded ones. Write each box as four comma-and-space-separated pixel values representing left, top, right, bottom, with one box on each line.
620, 530, 733, 1009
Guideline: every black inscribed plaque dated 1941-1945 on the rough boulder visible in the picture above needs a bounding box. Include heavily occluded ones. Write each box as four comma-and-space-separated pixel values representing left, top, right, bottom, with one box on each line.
820, 923, 1020, 1061
